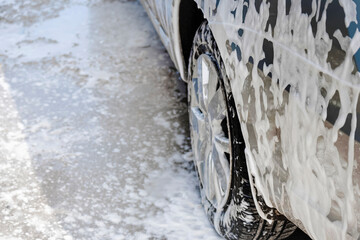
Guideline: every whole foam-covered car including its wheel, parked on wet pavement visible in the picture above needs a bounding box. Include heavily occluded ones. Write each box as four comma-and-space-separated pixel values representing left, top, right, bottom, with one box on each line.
141, 0, 360, 240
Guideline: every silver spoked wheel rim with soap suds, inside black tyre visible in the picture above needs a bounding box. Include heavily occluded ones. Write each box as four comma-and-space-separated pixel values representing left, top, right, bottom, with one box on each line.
189, 54, 231, 208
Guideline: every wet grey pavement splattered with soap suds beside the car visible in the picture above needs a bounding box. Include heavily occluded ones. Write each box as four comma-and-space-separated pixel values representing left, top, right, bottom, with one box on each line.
0, 0, 310, 240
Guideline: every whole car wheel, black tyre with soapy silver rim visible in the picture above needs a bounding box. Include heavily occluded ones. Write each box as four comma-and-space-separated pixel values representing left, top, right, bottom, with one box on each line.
188, 22, 296, 240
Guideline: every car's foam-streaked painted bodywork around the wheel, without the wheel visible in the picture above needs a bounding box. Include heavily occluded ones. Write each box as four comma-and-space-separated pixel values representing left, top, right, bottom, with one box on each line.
141, 0, 360, 239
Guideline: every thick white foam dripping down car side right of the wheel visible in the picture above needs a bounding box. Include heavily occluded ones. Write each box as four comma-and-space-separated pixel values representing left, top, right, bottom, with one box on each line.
197, 0, 360, 239
